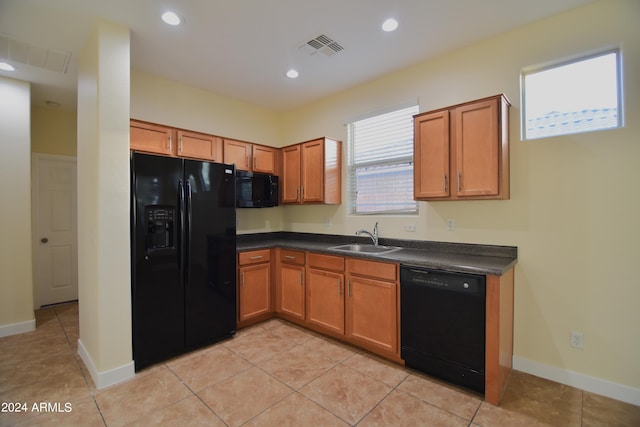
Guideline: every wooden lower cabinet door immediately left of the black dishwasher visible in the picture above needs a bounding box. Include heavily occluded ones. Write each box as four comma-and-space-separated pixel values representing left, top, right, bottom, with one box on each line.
346, 275, 398, 354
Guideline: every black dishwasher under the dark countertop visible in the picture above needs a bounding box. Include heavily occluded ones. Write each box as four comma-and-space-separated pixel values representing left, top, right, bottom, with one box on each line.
400, 265, 486, 393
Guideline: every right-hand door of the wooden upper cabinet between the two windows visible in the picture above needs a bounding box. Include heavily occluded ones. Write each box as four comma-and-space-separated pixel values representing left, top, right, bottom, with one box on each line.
452, 99, 501, 197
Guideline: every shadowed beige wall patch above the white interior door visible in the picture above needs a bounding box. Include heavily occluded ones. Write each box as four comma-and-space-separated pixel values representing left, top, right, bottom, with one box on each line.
31, 106, 78, 157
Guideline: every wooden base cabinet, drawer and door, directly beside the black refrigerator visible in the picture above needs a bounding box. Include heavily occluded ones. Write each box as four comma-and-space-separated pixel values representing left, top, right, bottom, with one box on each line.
238, 249, 272, 326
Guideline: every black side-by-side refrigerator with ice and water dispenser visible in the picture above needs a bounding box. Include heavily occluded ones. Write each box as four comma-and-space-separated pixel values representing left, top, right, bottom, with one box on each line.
131, 152, 236, 371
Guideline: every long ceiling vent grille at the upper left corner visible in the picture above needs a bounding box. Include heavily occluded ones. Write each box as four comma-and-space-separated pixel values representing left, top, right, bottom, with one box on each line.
0, 34, 71, 74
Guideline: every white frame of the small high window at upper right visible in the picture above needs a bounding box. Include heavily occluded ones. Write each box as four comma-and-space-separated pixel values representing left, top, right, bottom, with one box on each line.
520, 46, 624, 141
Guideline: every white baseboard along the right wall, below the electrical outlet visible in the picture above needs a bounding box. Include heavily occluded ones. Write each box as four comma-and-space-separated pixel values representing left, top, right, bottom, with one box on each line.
513, 356, 640, 406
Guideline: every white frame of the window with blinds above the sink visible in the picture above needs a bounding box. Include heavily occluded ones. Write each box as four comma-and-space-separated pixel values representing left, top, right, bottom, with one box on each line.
346, 104, 420, 216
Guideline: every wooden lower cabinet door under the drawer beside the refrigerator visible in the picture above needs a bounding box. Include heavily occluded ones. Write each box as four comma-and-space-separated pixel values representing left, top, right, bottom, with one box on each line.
238, 264, 271, 321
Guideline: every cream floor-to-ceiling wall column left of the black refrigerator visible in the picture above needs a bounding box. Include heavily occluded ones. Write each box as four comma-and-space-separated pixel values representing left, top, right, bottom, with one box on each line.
78, 20, 134, 388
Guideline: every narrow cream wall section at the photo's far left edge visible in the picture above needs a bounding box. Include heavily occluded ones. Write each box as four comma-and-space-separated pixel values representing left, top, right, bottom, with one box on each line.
0, 77, 35, 336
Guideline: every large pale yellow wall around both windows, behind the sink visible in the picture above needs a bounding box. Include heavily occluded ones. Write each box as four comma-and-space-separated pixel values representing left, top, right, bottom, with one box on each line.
283, 0, 640, 399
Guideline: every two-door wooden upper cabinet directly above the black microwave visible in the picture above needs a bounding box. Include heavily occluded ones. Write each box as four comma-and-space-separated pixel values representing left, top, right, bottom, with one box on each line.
224, 139, 277, 174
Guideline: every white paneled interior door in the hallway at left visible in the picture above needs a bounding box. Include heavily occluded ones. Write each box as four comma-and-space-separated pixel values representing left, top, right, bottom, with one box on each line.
33, 155, 78, 308
